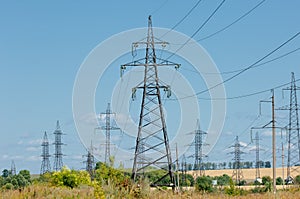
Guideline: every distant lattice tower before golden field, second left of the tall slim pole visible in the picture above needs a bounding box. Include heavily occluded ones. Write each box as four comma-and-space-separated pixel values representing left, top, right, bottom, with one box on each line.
232, 136, 244, 185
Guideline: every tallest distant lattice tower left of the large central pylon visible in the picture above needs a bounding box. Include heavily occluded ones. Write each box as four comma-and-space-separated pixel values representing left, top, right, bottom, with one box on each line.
96, 103, 120, 166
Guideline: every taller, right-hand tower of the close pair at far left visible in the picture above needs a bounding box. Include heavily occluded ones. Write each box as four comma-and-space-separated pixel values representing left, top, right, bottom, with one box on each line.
53, 120, 64, 171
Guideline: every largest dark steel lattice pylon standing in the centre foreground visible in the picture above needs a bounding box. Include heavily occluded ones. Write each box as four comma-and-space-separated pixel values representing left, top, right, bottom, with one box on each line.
121, 16, 180, 187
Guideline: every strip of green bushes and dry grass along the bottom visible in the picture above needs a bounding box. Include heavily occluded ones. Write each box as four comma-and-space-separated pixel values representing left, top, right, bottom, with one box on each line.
0, 162, 300, 199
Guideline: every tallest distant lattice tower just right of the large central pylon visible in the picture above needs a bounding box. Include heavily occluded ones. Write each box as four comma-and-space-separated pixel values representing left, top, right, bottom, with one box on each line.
194, 119, 207, 176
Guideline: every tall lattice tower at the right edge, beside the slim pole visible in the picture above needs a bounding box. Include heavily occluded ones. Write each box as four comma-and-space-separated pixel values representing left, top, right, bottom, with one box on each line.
284, 73, 300, 179
